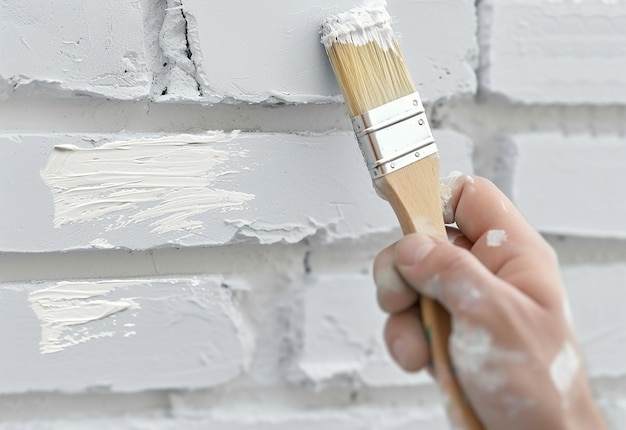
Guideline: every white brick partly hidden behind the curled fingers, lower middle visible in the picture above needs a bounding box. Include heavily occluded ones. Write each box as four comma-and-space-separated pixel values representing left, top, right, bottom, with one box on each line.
293, 273, 432, 386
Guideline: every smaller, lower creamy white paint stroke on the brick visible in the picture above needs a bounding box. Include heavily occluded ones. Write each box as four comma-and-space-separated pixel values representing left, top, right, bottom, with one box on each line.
28, 280, 148, 354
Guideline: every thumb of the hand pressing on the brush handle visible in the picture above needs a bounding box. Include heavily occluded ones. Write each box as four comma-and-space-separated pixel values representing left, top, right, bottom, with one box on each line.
394, 234, 508, 316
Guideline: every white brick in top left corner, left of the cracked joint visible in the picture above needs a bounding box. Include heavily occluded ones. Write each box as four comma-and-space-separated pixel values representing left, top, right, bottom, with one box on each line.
0, 0, 151, 99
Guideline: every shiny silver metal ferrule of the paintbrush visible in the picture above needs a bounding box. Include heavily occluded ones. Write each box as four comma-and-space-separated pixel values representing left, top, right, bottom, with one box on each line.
352, 92, 437, 179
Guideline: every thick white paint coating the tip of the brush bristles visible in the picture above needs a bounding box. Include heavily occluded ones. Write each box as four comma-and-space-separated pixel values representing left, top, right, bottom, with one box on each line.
320, 6, 395, 51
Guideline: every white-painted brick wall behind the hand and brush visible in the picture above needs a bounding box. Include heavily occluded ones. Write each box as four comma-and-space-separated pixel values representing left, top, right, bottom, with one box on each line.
0, 0, 626, 430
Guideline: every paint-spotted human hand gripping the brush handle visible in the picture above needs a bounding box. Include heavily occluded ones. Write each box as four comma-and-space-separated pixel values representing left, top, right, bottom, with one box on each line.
374, 175, 605, 430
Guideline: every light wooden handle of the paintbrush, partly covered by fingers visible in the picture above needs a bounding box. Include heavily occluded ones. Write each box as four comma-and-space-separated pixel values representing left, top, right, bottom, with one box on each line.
374, 154, 483, 430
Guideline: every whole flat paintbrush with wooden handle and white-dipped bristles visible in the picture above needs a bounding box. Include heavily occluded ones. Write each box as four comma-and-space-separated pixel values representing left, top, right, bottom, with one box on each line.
320, 7, 483, 429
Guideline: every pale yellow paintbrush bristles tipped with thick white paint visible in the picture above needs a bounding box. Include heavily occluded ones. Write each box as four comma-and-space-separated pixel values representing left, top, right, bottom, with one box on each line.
321, 8, 415, 116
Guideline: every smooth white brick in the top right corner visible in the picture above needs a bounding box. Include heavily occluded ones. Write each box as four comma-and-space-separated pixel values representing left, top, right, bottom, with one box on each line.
479, 0, 626, 104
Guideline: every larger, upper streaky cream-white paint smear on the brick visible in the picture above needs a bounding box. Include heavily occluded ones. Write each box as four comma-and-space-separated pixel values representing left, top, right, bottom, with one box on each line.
41, 131, 254, 233
